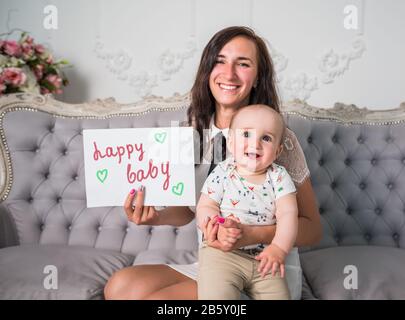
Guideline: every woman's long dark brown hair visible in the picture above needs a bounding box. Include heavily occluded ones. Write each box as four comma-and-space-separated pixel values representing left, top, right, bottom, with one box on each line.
187, 26, 280, 159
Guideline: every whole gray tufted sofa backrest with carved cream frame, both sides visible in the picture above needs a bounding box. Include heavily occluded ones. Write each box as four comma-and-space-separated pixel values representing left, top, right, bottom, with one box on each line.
0, 94, 405, 255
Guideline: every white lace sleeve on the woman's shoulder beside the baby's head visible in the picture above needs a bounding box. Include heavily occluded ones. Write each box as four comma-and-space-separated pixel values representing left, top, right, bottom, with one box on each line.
276, 128, 309, 186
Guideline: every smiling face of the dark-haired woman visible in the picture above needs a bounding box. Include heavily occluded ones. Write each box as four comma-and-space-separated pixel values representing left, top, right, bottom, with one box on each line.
209, 36, 258, 109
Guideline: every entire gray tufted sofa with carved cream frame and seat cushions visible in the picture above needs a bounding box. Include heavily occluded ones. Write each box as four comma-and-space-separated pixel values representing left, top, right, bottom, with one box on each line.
0, 94, 405, 299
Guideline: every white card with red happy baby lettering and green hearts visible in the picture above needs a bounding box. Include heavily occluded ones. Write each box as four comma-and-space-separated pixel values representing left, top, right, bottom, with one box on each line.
83, 127, 195, 208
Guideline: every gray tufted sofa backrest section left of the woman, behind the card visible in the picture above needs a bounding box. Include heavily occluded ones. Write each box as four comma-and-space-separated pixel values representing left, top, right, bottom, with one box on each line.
0, 94, 198, 255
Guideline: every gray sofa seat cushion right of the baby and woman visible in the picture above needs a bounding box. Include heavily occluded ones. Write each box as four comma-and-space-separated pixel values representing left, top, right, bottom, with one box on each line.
300, 246, 405, 300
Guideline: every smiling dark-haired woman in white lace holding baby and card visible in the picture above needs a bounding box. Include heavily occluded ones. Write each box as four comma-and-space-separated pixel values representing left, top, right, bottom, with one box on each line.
105, 27, 321, 299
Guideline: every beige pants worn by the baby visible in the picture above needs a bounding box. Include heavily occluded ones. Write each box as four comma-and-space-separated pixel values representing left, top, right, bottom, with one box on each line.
197, 246, 290, 300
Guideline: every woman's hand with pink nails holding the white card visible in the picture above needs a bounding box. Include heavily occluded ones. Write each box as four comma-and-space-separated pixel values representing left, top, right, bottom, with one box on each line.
124, 186, 159, 225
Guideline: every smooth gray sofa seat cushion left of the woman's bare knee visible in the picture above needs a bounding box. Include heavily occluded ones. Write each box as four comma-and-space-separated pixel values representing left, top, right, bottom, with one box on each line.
0, 245, 134, 299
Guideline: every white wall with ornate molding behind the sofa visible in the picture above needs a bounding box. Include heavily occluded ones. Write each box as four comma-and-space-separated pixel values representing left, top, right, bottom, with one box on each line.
0, 0, 405, 109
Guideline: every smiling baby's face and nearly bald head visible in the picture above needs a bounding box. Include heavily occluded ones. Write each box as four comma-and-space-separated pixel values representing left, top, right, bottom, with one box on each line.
229, 108, 283, 174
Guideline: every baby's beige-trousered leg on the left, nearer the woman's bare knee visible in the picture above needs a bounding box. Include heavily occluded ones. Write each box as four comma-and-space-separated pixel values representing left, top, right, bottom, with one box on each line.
197, 246, 246, 300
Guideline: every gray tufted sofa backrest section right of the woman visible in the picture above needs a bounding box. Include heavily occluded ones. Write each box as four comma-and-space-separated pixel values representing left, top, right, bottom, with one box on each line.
284, 102, 405, 248
